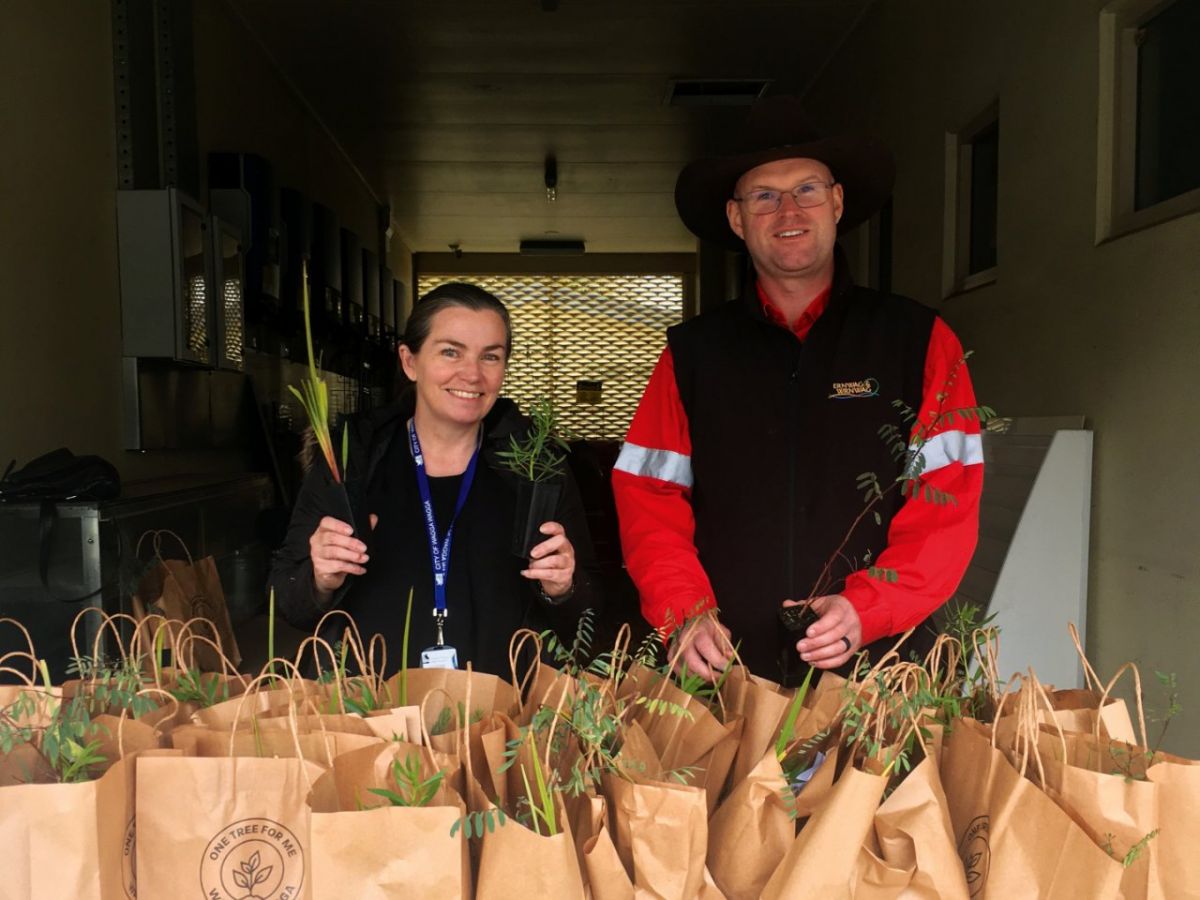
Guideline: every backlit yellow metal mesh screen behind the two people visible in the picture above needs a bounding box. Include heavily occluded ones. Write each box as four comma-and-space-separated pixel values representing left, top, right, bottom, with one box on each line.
418, 274, 683, 440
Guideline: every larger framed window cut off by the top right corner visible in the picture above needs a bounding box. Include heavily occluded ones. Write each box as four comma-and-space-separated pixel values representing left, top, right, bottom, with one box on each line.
1097, 0, 1200, 241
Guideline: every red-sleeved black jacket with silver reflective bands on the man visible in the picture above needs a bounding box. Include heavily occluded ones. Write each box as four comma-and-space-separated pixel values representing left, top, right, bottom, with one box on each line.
613, 259, 983, 682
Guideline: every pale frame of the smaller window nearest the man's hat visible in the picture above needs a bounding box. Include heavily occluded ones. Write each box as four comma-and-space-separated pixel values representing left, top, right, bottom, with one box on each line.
942, 100, 1000, 298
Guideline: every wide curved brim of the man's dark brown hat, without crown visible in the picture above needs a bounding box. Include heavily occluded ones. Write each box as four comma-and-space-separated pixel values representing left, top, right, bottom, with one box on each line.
676, 136, 895, 250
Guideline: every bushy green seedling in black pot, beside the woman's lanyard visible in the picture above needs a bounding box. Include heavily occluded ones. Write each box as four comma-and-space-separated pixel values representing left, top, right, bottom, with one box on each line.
497, 397, 569, 559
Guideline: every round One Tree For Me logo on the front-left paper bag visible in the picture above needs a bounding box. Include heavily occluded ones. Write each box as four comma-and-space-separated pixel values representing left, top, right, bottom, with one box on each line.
200, 818, 304, 900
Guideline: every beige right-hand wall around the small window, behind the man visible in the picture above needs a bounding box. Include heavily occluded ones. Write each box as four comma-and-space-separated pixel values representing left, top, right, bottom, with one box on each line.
806, 0, 1200, 754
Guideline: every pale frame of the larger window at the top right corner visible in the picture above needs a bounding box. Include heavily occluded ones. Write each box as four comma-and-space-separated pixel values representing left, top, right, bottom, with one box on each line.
1096, 0, 1200, 244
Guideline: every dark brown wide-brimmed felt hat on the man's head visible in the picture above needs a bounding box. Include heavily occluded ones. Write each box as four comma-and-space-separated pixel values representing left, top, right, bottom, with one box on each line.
676, 96, 895, 250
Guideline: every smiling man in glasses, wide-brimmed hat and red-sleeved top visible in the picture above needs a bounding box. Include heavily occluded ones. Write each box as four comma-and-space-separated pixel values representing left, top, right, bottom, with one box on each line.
613, 97, 983, 684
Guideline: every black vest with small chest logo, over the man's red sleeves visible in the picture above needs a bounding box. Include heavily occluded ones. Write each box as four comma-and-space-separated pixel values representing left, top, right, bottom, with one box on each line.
667, 262, 935, 684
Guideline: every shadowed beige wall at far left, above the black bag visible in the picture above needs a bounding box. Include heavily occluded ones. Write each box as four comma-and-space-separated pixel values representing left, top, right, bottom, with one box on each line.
0, 0, 121, 467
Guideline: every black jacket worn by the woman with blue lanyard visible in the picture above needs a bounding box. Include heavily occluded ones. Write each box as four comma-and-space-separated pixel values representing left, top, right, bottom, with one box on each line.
271, 395, 600, 674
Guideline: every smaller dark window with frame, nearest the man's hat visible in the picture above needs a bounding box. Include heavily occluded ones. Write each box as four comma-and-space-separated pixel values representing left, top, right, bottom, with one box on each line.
942, 103, 1000, 296
